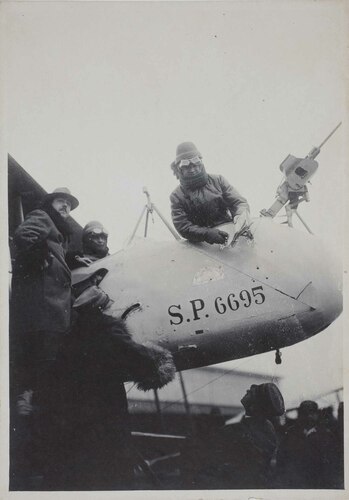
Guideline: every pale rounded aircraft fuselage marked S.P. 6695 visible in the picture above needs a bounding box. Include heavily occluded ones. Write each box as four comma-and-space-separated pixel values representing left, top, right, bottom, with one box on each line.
73, 218, 342, 370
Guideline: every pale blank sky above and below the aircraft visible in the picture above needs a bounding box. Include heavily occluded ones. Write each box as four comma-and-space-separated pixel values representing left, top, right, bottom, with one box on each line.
2, 1, 348, 412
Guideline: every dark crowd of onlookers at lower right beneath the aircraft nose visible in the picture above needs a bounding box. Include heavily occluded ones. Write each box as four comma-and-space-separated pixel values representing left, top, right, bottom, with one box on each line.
179, 394, 344, 489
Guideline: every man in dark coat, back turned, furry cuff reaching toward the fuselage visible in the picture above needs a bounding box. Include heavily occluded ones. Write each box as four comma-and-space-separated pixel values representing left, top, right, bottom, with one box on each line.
57, 284, 175, 490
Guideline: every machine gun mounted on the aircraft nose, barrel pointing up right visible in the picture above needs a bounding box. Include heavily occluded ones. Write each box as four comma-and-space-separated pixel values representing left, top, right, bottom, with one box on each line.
260, 122, 342, 233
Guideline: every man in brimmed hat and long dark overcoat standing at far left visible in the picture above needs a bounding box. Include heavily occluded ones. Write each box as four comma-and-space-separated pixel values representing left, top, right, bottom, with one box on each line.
10, 188, 79, 489
